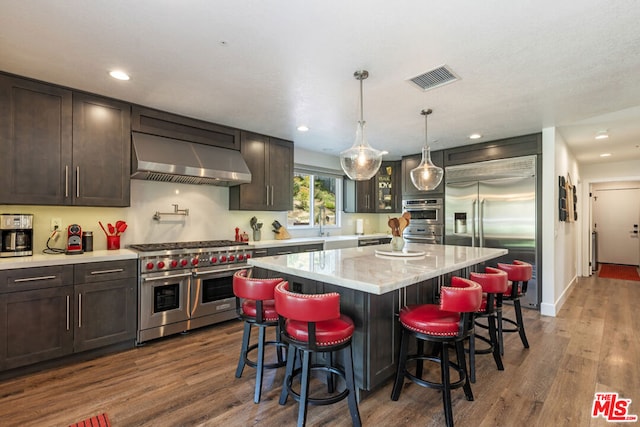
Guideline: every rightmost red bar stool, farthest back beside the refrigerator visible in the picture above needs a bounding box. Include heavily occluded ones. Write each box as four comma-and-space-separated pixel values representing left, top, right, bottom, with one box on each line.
498, 260, 533, 354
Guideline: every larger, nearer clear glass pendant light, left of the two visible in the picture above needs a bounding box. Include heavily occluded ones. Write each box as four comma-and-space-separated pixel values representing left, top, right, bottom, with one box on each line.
340, 70, 387, 181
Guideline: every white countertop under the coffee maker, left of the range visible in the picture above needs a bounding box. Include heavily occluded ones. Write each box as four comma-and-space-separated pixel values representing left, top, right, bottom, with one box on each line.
0, 249, 138, 270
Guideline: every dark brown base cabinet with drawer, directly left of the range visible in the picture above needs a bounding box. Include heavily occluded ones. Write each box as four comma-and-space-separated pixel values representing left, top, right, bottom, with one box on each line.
74, 260, 137, 352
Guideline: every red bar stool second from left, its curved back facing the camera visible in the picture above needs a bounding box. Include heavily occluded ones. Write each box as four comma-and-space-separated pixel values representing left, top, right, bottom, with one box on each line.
275, 282, 362, 427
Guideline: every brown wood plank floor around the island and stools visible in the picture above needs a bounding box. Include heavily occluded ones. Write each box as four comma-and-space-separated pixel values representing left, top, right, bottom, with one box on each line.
0, 277, 640, 427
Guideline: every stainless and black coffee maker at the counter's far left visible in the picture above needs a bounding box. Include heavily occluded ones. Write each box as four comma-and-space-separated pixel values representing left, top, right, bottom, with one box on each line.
0, 214, 33, 258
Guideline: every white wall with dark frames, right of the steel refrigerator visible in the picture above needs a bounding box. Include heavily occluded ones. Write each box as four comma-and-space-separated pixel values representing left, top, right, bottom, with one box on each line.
540, 128, 583, 316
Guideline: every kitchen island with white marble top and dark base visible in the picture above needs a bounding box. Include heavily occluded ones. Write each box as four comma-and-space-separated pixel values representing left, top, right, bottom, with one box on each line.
249, 243, 507, 400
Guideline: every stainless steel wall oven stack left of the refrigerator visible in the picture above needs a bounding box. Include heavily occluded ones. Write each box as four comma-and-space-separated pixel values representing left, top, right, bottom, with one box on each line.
402, 198, 444, 244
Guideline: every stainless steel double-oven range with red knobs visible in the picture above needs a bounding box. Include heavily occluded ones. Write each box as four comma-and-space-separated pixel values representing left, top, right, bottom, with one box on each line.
129, 240, 253, 343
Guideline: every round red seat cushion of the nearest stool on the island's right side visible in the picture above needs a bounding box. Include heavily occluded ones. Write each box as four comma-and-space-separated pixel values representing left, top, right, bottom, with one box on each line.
400, 304, 460, 336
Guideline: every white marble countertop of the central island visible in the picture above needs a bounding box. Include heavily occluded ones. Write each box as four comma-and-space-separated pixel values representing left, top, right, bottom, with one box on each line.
249, 243, 508, 295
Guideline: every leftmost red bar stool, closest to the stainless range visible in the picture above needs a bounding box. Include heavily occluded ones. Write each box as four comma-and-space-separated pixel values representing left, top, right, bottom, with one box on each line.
233, 270, 286, 403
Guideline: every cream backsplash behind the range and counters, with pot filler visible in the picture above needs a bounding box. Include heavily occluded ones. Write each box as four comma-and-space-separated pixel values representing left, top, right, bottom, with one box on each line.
0, 180, 388, 253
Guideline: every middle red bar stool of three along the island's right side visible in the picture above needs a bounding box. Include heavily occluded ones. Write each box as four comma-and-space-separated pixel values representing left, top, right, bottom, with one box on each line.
469, 267, 509, 383
